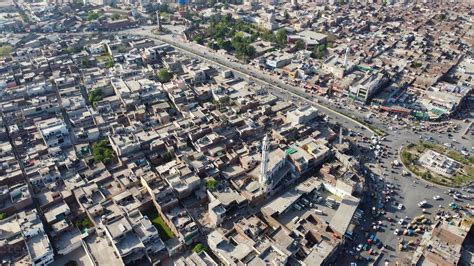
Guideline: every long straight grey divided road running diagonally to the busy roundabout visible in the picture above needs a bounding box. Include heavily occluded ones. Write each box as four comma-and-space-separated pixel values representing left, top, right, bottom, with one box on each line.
122, 26, 380, 135
